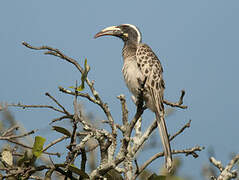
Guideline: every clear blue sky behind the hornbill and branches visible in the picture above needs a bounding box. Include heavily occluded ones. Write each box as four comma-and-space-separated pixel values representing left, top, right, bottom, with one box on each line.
0, 0, 239, 179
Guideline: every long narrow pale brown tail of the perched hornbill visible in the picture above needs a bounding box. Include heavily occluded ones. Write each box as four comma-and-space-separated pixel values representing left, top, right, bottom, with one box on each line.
155, 113, 173, 172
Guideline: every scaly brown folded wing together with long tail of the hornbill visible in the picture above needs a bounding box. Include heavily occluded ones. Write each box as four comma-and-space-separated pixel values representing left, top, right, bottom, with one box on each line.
136, 44, 172, 170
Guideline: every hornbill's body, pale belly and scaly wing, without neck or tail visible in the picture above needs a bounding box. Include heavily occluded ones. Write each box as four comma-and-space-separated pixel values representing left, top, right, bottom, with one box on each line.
122, 44, 164, 112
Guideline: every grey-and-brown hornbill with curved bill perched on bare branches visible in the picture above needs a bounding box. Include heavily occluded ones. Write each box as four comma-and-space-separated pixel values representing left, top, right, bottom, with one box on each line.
94, 24, 173, 172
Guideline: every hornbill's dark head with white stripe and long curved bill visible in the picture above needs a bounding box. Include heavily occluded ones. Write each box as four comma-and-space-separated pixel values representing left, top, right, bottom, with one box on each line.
95, 24, 141, 44
